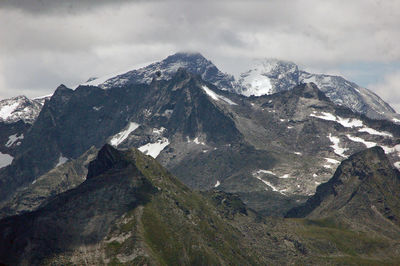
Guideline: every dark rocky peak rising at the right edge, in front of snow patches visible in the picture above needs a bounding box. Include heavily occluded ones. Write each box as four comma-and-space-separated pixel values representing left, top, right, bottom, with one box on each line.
287, 147, 400, 235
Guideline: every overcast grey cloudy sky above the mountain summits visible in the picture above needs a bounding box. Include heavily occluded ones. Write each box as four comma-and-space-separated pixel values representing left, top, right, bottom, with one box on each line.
0, 0, 400, 112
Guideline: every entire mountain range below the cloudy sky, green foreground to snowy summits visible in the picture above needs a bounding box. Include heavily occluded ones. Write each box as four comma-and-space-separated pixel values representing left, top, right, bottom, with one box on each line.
0, 53, 400, 265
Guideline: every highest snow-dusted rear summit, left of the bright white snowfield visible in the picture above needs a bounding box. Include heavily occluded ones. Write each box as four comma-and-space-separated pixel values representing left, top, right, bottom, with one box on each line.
83, 53, 234, 90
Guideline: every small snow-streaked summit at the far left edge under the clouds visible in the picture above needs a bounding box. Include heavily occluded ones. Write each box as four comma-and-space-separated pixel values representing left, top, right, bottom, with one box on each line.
0, 95, 45, 124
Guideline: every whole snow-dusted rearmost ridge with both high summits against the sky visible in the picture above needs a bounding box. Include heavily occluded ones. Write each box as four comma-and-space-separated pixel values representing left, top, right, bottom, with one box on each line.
83, 53, 400, 122
